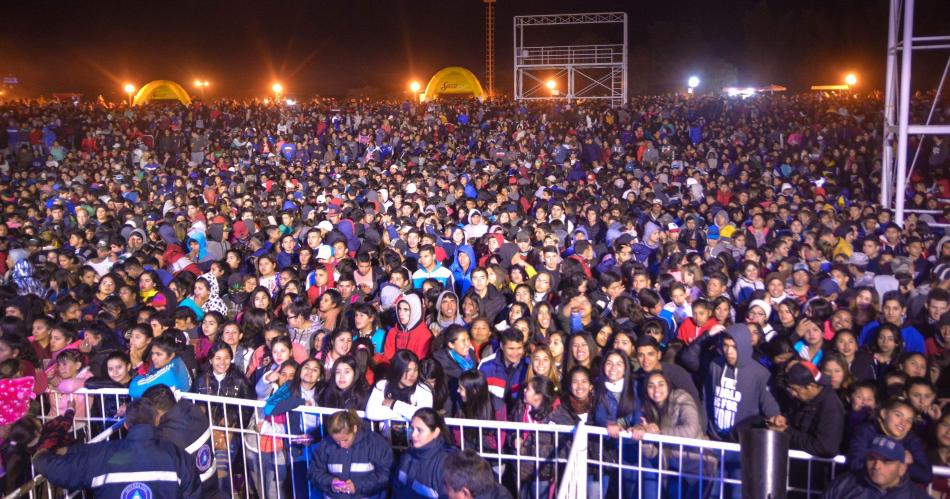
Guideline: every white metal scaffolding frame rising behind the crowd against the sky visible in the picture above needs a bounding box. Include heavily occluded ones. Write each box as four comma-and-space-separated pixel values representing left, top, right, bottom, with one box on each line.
514, 12, 628, 106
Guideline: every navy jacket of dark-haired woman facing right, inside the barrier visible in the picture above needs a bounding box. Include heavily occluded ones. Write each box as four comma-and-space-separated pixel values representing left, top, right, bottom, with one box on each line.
393, 437, 457, 498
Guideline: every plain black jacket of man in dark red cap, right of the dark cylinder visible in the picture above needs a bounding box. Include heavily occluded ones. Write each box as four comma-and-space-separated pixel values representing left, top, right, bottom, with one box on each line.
786, 386, 844, 457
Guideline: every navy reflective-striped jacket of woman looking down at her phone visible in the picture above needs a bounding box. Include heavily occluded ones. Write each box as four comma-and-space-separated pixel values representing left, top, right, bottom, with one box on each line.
308, 428, 393, 499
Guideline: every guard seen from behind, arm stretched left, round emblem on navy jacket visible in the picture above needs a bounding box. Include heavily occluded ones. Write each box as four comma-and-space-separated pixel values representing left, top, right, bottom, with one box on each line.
33, 400, 201, 499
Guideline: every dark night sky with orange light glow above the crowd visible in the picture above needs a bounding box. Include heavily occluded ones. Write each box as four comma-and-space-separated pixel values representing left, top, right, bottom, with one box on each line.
0, 0, 950, 97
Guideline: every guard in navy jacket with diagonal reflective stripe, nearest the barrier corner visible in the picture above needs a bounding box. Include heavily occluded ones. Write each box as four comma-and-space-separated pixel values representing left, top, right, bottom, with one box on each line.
142, 385, 219, 498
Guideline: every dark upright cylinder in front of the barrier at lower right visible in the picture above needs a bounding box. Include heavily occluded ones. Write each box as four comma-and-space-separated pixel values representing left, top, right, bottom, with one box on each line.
739, 428, 789, 499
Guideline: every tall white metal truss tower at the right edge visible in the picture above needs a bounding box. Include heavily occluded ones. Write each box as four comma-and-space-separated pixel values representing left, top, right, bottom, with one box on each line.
881, 0, 950, 225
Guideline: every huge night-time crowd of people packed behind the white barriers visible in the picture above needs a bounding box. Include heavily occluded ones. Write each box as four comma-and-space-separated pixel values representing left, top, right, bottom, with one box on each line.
0, 93, 950, 498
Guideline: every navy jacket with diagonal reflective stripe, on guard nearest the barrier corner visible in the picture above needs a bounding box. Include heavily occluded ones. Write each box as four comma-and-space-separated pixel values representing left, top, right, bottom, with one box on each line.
156, 399, 218, 497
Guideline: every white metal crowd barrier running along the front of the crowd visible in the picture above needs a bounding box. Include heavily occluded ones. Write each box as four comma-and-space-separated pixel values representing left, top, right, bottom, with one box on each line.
4, 389, 950, 499
